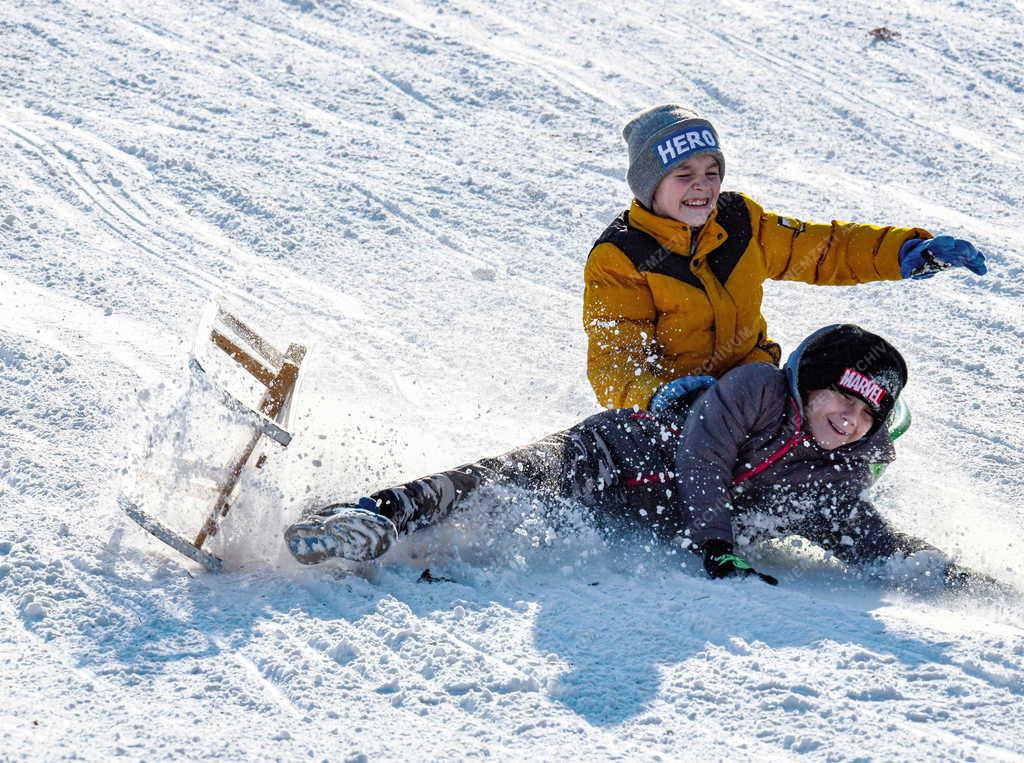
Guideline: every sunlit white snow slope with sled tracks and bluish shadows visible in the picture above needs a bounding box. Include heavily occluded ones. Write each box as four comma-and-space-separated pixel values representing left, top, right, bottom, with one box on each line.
0, 0, 1024, 760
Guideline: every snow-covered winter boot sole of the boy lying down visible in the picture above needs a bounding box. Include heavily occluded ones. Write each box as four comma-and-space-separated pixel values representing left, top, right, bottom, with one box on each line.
285, 498, 398, 564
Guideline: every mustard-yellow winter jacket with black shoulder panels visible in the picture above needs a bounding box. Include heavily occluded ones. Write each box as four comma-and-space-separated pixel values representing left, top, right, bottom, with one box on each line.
584, 193, 932, 408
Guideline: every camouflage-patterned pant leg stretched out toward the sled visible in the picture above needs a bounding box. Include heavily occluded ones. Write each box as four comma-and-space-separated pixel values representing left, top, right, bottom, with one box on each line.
371, 411, 618, 532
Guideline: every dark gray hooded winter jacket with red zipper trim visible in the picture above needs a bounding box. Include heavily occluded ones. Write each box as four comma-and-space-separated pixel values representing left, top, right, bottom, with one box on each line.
593, 335, 932, 562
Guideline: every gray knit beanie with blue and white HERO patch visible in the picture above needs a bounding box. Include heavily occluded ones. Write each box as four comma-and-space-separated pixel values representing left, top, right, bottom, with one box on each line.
623, 103, 725, 209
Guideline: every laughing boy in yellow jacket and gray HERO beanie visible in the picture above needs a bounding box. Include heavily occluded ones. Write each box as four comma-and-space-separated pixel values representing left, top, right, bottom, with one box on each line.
584, 104, 985, 408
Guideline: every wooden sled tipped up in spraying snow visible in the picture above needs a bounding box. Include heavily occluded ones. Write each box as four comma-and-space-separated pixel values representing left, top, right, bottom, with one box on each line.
118, 304, 306, 571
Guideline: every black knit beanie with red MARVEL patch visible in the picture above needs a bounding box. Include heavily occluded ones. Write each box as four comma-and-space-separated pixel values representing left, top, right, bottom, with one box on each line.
798, 324, 907, 421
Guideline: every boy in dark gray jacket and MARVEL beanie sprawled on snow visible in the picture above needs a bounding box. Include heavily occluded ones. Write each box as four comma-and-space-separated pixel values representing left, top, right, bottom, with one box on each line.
285, 325, 966, 585
